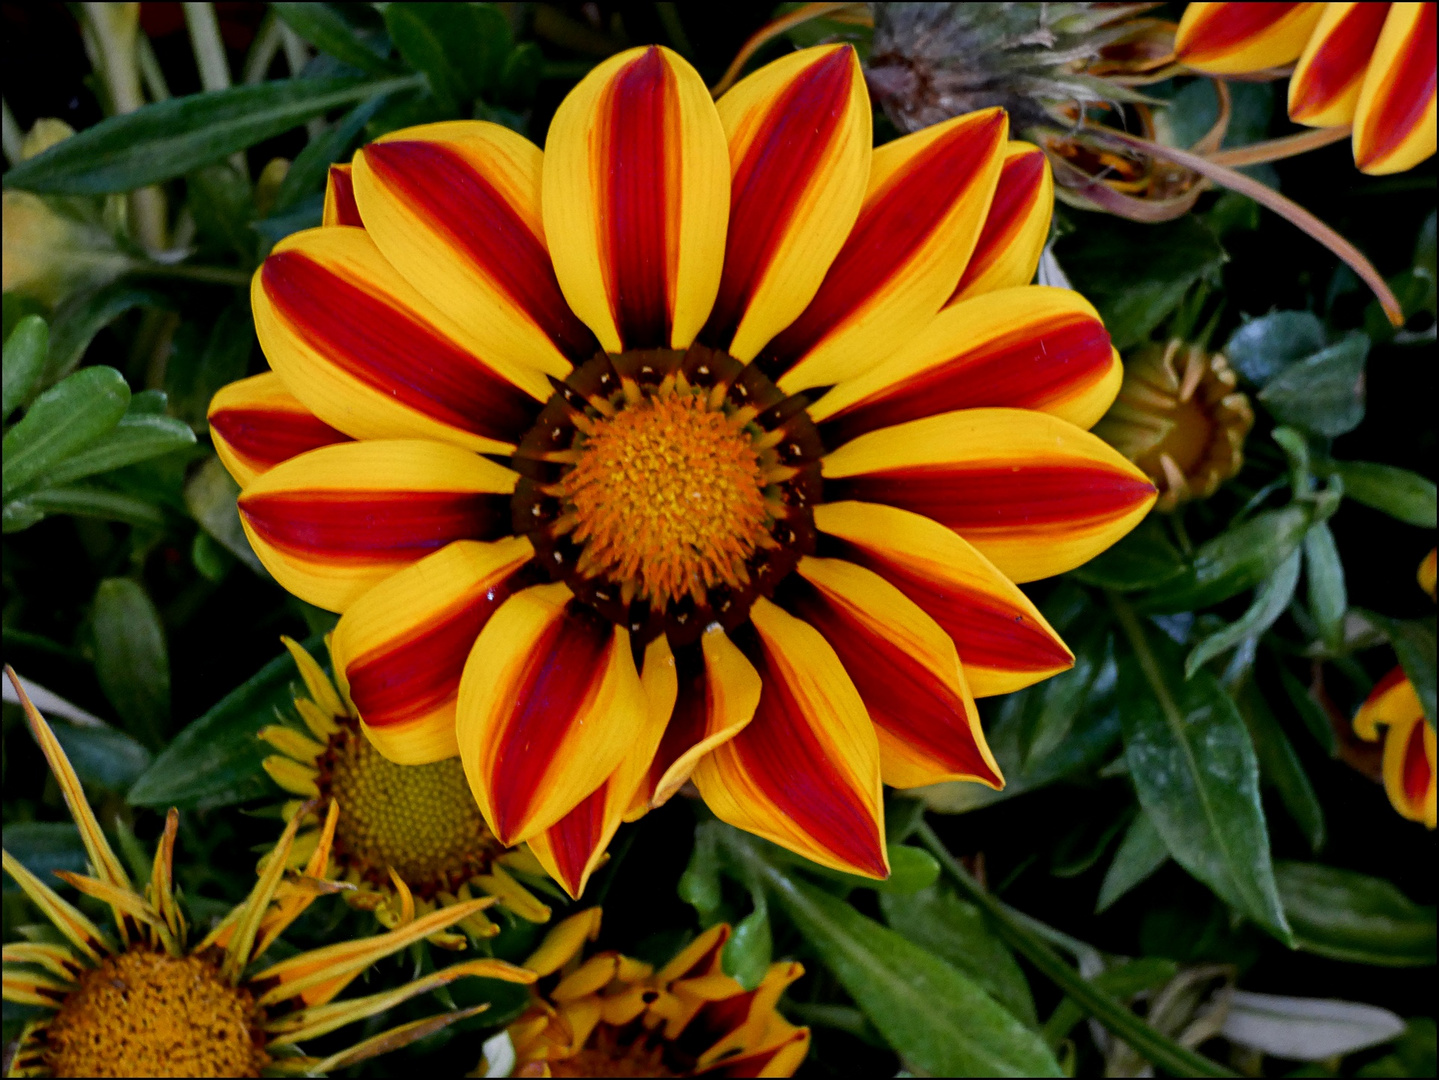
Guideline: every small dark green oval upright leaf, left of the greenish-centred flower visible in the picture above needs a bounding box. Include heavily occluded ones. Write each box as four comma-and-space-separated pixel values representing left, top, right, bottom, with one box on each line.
94, 578, 170, 746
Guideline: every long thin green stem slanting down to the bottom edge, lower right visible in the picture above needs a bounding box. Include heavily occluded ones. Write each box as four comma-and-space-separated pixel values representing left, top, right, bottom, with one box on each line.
917, 821, 1236, 1076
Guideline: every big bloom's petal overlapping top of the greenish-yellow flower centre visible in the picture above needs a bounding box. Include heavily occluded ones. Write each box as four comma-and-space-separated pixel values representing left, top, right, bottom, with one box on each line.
330, 536, 534, 765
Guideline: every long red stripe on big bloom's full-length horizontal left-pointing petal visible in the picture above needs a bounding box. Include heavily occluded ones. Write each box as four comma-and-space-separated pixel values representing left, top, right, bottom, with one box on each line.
239, 490, 509, 562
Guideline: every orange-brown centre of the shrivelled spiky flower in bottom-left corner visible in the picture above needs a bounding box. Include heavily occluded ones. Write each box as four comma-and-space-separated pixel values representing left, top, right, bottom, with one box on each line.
45, 952, 271, 1076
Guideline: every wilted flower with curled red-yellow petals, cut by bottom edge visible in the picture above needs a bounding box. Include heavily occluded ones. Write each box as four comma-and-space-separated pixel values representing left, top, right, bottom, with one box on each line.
509, 907, 809, 1077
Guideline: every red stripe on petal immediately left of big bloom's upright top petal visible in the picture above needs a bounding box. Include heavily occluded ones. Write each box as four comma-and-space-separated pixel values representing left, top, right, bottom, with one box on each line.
364, 139, 599, 360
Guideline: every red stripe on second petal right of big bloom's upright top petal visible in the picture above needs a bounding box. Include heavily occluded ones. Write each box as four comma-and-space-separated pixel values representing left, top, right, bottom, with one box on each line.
766, 112, 1007, 378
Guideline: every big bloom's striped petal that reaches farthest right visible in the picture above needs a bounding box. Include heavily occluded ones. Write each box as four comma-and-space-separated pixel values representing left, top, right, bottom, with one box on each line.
823, 408, 1158, 581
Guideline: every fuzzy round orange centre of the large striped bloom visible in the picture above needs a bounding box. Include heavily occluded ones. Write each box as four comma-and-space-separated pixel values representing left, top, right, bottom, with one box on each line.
560, 393, 768, 607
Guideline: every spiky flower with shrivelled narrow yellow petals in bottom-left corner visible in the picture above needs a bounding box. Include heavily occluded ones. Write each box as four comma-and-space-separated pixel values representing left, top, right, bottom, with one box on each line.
4, 669, 535, 1076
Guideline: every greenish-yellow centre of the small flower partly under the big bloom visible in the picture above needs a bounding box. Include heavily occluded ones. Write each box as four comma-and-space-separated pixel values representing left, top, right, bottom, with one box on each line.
321, 726, 501, 897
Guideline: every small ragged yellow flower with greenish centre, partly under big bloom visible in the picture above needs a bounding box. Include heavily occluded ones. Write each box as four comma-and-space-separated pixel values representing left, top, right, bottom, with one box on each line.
259, 637, 550, 949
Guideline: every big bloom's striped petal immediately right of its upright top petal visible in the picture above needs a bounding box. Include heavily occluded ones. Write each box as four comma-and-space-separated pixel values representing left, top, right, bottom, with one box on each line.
705, 45, 872, 361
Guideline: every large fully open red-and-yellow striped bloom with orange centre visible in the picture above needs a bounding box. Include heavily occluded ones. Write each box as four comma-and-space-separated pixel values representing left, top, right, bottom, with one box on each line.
210, 46, 1156, 894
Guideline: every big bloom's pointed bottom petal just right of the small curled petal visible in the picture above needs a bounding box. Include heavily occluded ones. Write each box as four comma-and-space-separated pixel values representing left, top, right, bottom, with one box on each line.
694, 597, 889, 877
